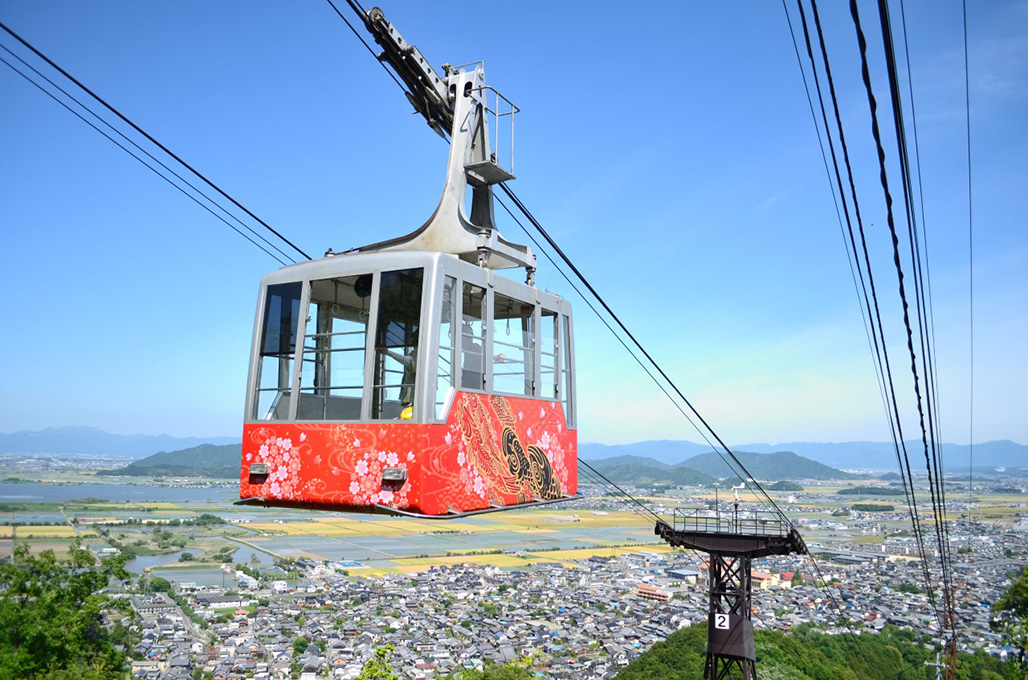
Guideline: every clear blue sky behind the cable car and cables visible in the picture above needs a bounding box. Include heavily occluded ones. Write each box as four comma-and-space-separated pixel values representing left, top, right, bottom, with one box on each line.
0, 0, 1028, 443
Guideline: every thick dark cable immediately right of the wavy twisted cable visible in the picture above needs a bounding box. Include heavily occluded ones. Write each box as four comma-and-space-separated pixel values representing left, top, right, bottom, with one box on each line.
878, 0, 956, 635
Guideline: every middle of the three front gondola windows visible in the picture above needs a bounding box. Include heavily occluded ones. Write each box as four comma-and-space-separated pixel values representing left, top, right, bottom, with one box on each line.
296, 274, 371, 421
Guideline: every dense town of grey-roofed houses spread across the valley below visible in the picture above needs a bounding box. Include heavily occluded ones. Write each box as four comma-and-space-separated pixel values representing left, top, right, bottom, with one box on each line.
124, 510, 1028, 680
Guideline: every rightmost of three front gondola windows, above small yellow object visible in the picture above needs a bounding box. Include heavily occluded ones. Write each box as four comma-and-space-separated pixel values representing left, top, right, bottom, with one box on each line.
371, 267, 425, 420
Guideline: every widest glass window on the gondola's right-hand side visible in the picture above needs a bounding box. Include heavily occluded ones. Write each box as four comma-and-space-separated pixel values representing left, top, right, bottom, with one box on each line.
492, 293, 536, 397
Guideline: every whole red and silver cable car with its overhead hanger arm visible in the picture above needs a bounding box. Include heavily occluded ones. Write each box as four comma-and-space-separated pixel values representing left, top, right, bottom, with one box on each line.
240, 8, 578, 517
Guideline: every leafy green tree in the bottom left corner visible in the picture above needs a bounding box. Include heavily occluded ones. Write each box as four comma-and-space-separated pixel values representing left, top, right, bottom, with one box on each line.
0, 541, 129, 680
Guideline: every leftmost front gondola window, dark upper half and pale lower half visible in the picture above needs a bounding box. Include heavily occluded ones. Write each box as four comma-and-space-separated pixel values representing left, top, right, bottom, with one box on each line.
253, 282, 303, 420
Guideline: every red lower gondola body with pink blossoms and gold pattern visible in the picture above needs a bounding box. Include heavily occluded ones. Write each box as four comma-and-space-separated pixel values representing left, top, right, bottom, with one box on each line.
240, 392, 578, 515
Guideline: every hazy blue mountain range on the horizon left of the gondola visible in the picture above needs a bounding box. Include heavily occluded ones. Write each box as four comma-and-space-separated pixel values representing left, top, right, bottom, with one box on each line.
0, 427, 240, 458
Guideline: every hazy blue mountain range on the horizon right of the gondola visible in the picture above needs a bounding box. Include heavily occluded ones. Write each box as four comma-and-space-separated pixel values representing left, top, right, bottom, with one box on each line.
579, 439, 1028, 474
